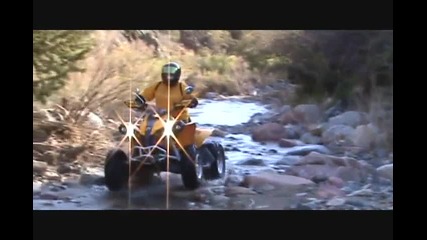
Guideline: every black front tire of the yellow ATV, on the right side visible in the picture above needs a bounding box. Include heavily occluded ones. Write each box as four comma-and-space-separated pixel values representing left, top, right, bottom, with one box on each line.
180, 146, 203, 190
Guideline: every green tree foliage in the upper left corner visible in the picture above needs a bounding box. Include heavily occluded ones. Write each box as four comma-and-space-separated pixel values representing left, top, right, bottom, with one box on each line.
33, 30, 94, 103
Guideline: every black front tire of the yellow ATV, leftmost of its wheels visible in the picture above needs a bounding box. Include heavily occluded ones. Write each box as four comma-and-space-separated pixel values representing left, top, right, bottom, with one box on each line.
104, 149, 129, 191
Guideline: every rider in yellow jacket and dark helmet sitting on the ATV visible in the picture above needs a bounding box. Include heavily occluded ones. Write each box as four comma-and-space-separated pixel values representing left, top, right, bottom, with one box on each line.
141, 62, 198, 122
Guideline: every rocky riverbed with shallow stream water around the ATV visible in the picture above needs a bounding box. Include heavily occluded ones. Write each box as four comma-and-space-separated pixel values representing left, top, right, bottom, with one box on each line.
33, 97, 393, 210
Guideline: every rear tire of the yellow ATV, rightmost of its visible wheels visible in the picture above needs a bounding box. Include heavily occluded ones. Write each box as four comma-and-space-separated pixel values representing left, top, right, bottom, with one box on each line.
205, 143, 226, 179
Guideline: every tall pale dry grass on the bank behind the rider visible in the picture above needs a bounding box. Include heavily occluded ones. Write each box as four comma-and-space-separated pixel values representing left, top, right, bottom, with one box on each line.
46, 31, 258, 122
